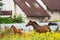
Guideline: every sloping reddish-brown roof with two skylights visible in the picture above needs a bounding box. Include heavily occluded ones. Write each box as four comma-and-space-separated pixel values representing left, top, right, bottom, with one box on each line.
14, 0, 50, 17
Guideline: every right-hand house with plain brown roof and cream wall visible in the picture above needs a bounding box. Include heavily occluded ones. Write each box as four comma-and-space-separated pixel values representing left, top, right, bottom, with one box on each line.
41, 0, 60, 20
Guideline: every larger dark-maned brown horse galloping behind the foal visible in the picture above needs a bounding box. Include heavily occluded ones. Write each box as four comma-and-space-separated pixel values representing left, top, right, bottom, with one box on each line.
26, 20, 51, 33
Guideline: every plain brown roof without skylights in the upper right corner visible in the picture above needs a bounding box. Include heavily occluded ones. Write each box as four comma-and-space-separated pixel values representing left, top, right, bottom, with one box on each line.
42, 0, 60, 11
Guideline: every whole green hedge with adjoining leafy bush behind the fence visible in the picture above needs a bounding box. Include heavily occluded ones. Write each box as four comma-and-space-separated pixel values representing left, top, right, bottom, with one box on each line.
0, 16, 24, 24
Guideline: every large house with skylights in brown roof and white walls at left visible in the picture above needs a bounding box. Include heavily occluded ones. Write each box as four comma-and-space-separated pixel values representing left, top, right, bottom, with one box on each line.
2, 0, 50, 22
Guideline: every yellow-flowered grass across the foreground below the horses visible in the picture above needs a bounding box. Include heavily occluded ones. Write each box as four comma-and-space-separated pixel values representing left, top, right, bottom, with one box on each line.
0, 31, 60, 40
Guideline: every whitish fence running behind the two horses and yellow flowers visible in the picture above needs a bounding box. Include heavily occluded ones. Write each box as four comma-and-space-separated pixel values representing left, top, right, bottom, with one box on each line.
0, 22, 60, 32
